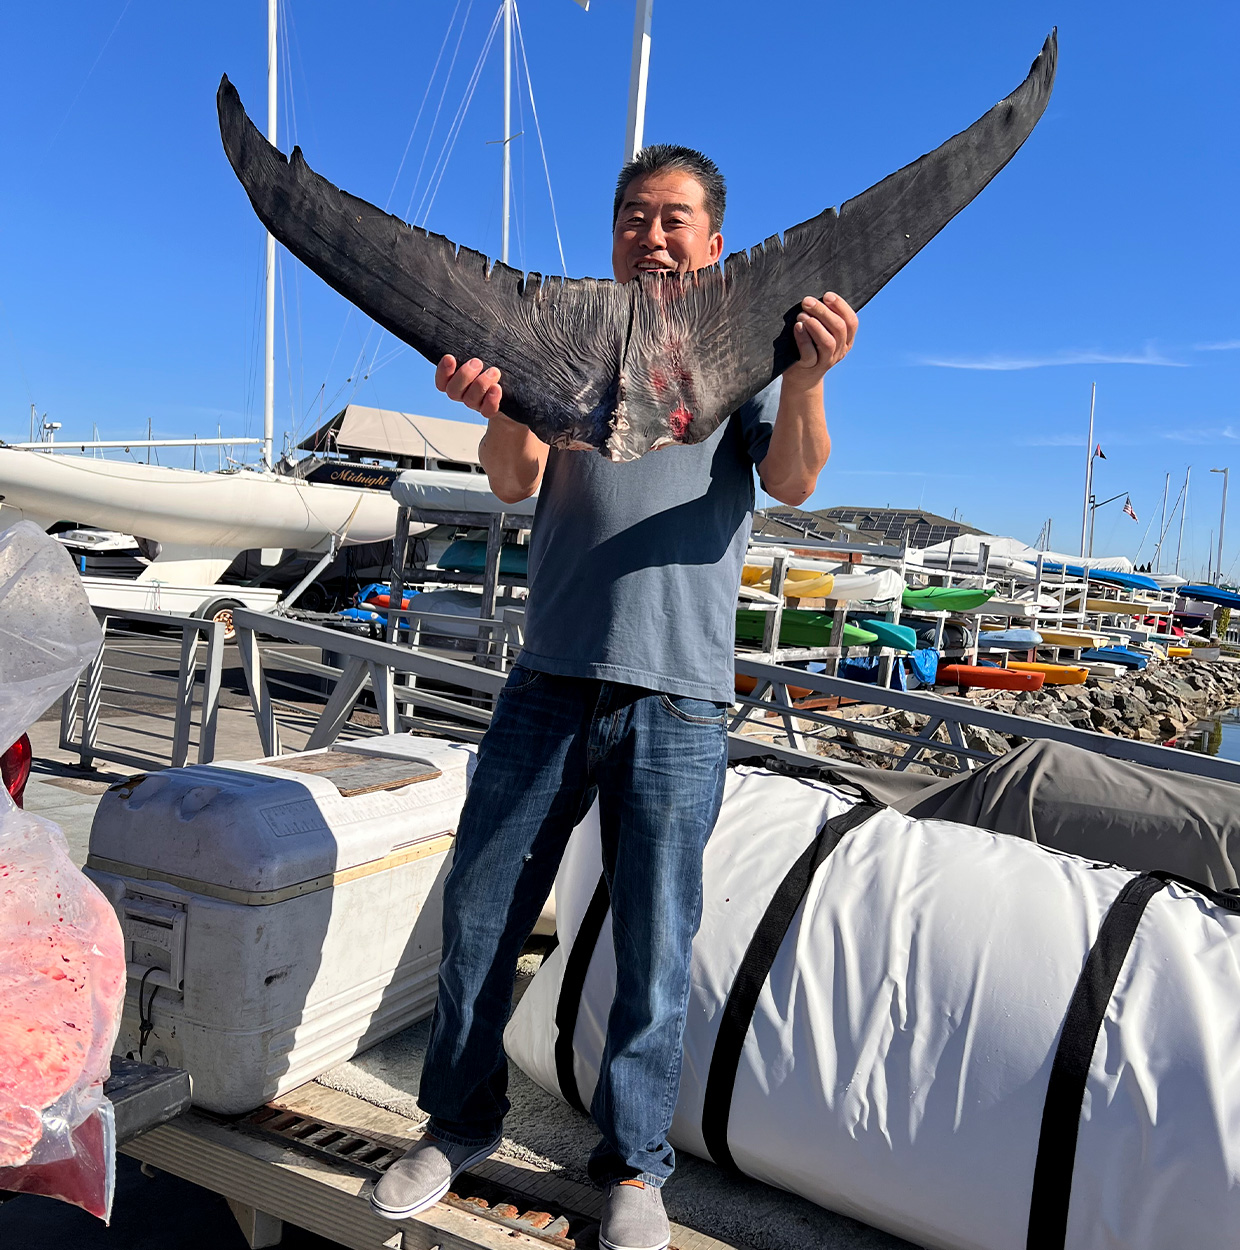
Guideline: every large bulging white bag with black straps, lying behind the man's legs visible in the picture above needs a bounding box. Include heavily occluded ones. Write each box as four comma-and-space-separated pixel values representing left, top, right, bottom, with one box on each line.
505, 768, 1240, 1250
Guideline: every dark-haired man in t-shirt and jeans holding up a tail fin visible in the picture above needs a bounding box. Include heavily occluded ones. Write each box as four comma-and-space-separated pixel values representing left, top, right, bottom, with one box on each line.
373, 145, 856, 1250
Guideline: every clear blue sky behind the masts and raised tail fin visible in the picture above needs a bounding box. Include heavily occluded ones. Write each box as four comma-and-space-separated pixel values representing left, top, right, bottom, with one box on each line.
0, 0, 1240, 575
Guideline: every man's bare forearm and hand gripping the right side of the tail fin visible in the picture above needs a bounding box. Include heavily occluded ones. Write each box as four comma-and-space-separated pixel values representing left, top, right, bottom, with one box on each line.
758, 291, 856, 508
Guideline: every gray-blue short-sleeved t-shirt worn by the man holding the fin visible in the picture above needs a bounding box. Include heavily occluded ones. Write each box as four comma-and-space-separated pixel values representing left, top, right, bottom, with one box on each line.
521, 379, 780, 703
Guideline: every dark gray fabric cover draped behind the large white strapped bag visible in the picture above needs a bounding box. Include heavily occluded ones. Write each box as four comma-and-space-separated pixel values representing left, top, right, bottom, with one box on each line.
900, 741, 1240, 890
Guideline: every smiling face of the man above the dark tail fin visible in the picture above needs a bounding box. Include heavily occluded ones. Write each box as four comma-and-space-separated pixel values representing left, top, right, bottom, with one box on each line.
611, 170, 724, 283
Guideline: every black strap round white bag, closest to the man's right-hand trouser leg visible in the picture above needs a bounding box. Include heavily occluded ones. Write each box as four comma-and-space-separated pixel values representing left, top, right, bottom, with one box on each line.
701, 800, 883, 1171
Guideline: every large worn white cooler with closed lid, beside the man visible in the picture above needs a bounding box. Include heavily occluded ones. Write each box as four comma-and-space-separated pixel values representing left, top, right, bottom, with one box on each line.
86, 735, 474, 1114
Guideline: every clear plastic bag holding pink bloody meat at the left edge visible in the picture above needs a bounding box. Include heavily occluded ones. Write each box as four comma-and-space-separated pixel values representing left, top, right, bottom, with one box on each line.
0, 521, 125, 1219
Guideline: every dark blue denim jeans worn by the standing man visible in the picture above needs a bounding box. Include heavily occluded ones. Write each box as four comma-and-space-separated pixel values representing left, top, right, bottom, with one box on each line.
419, 666, 728, 1185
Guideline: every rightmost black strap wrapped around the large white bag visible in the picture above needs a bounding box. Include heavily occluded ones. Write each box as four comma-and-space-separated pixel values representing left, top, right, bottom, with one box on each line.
1025, 873, 1240, 1250
